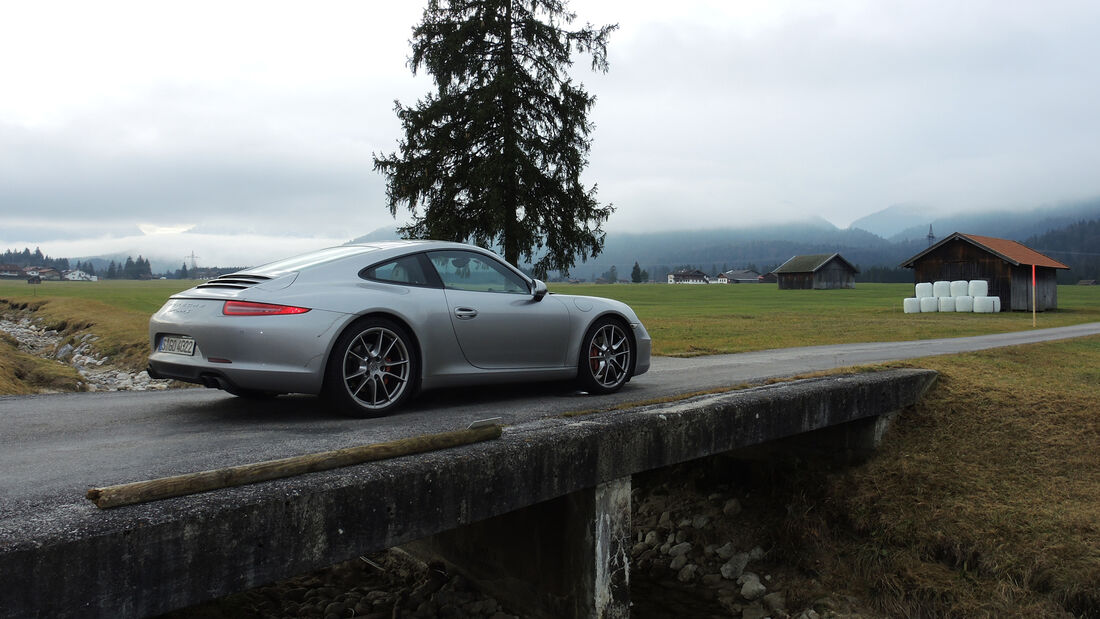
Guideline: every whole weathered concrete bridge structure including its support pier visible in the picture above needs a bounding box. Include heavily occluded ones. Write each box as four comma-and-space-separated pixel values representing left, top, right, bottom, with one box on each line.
0, 369, 936, 618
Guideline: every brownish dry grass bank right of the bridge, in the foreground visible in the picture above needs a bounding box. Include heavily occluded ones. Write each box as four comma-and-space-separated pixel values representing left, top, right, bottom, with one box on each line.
790, 338, 1100, 617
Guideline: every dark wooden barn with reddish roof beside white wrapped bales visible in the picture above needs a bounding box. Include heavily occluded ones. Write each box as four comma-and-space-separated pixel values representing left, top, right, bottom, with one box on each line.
901, 232, 1069, 311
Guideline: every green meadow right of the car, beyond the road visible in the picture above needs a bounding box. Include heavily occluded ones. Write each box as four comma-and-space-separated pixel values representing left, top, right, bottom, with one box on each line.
552, 284, 1100, 356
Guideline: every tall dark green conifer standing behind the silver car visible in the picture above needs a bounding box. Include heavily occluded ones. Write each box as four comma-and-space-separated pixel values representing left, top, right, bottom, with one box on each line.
374, 0, 618, 276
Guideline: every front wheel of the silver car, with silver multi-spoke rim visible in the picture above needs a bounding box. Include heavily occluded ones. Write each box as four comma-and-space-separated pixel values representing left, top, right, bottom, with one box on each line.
578, 317, 635, 394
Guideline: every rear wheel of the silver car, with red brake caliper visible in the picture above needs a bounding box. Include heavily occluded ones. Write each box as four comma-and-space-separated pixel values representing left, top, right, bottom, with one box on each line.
323, 317, 420, 417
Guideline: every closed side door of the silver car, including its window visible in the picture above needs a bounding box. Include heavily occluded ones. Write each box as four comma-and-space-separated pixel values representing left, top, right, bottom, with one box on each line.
428, 250, 569, 369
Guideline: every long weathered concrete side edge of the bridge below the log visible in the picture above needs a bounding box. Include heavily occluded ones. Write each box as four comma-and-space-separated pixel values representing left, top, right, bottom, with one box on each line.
0, 371, 935, 618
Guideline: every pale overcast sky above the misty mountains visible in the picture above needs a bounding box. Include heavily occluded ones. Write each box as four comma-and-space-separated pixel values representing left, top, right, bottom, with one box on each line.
0, 0, 1100, 265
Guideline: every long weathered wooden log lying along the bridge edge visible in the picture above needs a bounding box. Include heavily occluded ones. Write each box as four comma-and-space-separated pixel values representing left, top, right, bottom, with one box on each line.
86, 424, 502, 509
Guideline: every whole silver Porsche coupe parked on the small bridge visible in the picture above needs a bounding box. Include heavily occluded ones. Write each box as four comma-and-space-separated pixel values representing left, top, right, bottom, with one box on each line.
149, 241, 650, 417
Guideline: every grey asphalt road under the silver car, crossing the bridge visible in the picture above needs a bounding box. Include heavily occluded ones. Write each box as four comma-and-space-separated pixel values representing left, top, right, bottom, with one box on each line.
0, 322, 1100, 537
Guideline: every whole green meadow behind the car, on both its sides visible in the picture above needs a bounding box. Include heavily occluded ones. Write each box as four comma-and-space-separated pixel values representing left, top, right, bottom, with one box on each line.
0, 279, 1100, 366
